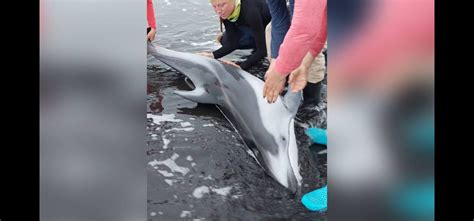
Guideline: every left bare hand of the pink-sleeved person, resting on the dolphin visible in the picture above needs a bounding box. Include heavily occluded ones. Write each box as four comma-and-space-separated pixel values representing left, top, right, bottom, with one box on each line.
263, 62, 286, 103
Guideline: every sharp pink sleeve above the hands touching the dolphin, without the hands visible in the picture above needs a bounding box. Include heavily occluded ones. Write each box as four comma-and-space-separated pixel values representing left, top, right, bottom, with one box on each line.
275, 0, 327, 75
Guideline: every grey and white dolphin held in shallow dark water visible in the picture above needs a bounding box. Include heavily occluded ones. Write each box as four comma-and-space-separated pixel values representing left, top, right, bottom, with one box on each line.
147, 42, 302, 193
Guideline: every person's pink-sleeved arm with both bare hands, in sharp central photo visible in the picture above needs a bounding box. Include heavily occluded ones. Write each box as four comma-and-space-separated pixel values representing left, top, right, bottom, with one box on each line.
263, 0, 327, 103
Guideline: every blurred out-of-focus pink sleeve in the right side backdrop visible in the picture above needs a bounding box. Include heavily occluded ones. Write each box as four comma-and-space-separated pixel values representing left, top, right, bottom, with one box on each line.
331, 0, 434, 78
